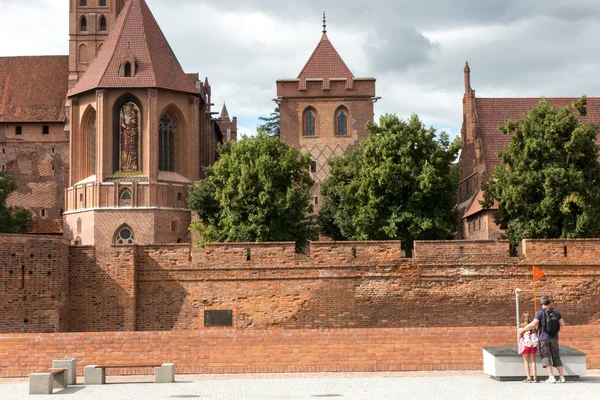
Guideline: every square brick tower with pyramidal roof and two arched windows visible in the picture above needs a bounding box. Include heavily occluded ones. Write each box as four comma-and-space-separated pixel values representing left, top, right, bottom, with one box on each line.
276, 14, 377, 210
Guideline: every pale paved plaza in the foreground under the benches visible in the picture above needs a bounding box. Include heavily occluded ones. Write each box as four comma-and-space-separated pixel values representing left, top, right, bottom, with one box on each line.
0, 371, 600, 400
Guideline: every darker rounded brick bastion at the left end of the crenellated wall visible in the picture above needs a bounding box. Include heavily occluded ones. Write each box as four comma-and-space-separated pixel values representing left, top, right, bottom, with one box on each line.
0, 234, 69, 332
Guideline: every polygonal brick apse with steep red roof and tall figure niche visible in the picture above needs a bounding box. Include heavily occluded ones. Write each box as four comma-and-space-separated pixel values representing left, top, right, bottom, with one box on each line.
64, 0, 202, 246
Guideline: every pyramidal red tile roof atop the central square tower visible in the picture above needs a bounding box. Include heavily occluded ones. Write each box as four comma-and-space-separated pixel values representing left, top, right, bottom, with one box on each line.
298, 33, 354, 86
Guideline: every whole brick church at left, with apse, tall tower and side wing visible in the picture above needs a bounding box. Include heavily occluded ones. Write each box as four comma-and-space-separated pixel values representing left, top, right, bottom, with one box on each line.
0, 0, 237, 245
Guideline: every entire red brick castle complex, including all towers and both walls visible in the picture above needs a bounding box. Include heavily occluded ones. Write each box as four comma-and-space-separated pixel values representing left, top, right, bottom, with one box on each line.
0, 0, 600, 377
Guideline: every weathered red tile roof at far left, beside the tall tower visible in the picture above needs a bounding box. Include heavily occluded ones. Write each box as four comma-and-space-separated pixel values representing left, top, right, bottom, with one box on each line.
0, 56, 69, 123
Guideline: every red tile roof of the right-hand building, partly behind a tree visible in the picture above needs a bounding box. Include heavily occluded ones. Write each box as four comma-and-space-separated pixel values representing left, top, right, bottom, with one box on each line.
475, 97, 600, 177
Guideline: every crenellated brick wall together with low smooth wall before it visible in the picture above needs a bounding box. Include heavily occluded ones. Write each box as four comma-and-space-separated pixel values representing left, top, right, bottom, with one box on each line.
0, 235, 600, 377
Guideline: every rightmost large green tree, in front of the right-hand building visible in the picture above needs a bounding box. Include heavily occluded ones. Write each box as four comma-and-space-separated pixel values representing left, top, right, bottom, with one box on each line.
482, 97, 600, 245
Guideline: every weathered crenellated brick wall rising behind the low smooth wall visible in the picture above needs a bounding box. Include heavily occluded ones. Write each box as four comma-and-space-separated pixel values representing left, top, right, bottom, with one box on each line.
0, 235, 600, 333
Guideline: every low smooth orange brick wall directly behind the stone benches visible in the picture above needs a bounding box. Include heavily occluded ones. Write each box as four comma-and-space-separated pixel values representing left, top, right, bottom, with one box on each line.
0, 326, 600, 377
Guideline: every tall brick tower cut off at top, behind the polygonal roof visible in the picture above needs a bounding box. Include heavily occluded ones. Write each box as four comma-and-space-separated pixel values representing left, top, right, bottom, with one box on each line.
69, 0, 126, 89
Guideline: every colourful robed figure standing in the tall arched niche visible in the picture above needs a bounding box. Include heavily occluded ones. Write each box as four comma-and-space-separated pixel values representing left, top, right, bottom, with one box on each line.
120, 102, 140, 172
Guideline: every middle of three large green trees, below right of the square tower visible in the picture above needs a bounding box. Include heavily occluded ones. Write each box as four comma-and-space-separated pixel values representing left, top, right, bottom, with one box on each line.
318, 115, 460, 250
